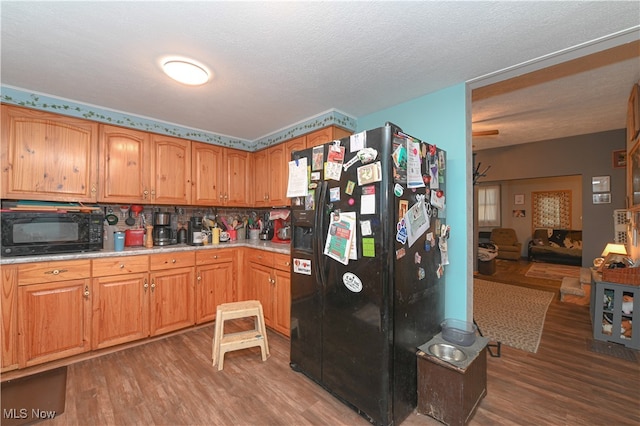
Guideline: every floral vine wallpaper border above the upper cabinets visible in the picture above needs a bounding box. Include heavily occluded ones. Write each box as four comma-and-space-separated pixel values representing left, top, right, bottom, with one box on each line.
0, 86, 357, 151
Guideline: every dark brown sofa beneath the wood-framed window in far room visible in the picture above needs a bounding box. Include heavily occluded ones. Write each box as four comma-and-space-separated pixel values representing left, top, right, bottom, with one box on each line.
529, 228, 582, 266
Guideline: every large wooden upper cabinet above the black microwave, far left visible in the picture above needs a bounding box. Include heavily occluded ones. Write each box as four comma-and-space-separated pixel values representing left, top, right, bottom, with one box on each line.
0, 105, 98, 202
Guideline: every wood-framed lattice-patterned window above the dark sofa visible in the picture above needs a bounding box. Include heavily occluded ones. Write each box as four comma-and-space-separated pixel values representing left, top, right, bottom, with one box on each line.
531, 191, 571, 229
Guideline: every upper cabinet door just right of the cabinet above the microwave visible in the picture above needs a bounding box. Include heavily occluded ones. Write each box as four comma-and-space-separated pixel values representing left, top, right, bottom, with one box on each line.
98, 125, 151, 203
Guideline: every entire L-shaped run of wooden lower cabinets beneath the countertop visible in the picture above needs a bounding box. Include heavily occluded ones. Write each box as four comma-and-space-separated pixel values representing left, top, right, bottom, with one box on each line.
5, 248, 291, 372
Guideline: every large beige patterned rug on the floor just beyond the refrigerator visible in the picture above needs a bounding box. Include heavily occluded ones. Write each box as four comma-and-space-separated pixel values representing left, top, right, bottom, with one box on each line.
473, 279, 554, 353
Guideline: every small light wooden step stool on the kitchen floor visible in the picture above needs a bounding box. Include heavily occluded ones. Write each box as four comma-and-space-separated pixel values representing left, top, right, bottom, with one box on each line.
212, 300, 269, 371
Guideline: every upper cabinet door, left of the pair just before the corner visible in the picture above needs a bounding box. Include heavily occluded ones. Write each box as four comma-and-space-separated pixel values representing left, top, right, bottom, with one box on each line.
191, 142, 225, 206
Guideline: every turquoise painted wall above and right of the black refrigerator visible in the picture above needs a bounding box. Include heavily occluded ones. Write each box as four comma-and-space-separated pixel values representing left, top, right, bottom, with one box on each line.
357, 83, 473, 320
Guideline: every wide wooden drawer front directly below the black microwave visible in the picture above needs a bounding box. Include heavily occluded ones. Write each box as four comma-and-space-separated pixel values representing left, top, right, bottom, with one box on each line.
18, 259, 91, 285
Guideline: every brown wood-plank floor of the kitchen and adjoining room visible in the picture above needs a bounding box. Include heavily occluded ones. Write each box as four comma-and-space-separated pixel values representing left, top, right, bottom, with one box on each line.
22, 265, 640, 426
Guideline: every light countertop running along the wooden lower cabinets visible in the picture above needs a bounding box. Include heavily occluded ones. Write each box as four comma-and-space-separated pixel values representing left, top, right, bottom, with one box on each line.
0, 240, 291, 265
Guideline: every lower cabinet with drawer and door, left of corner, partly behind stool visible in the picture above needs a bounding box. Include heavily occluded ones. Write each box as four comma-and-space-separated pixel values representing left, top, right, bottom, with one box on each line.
196, 249, 237, 324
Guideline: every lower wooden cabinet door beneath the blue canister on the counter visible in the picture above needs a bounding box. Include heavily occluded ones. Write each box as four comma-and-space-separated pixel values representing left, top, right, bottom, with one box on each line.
91, 273, 149, 349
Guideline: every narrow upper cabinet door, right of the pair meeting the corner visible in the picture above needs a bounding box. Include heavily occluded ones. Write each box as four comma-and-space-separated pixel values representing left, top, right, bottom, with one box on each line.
225, 149, 253, 207
